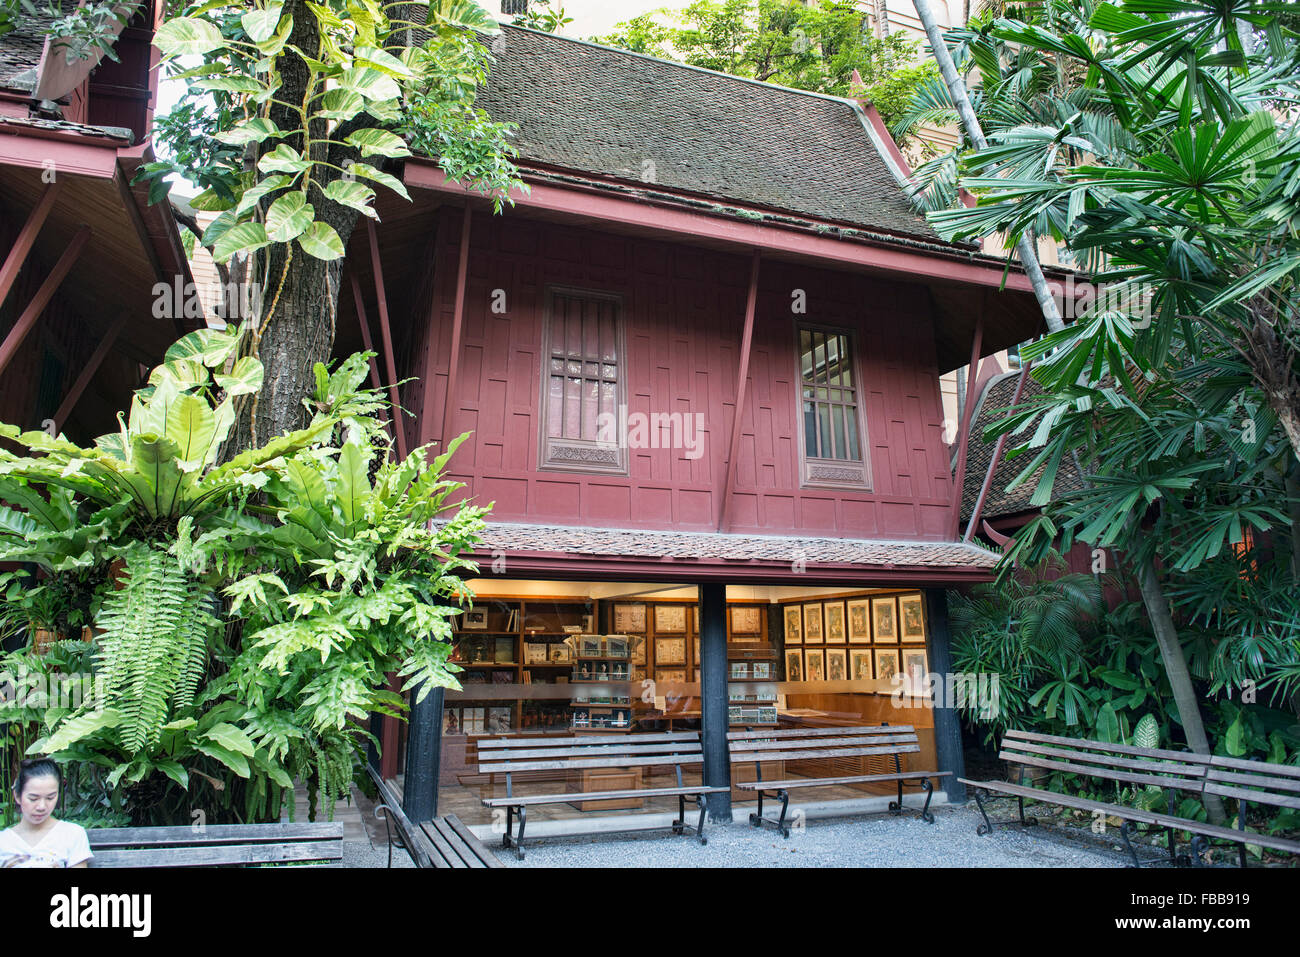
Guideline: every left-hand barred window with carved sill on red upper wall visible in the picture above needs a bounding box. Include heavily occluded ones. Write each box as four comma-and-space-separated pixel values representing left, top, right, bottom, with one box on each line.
540, 286, 627, 473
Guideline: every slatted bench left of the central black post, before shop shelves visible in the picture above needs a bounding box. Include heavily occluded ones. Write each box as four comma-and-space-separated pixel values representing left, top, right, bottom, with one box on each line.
478, 732, 729, 861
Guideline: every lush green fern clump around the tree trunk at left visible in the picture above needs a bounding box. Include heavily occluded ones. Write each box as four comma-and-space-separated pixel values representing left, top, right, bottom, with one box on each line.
0, 330, 486, 823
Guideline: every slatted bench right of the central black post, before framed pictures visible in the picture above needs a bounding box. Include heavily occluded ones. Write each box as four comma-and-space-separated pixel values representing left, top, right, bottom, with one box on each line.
727, 724, 952, 837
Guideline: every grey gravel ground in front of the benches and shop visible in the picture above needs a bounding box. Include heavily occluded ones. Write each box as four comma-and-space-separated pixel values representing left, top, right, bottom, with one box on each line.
493, 807, 1125, 867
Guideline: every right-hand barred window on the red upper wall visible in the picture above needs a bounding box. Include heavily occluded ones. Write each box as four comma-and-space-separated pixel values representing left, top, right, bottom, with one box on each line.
798, 325, 870, 488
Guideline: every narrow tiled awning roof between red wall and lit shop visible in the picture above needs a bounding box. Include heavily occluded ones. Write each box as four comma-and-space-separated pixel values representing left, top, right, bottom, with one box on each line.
454, 523, 998, 568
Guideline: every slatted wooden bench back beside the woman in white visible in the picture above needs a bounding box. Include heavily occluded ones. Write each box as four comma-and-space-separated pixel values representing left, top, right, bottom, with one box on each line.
86, 822, 343, 867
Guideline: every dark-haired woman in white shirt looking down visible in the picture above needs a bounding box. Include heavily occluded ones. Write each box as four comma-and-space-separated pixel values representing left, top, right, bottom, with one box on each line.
0, 758, 91, 867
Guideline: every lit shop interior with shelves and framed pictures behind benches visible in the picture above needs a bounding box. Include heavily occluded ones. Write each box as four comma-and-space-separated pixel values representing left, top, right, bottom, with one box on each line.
410, 579, 935, 826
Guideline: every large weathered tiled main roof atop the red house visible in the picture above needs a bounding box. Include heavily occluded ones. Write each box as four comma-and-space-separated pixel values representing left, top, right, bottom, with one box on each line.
477, 26, 943, 243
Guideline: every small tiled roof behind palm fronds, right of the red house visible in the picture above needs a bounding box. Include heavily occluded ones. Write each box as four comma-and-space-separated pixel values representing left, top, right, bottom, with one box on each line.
962, 369, 1084, 520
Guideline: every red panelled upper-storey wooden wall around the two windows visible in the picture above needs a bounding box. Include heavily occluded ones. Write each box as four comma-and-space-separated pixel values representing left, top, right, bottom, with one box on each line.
403, 209, 952, 540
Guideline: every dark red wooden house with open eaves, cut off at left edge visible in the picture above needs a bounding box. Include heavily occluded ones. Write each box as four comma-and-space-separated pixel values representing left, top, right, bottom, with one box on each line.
0, 0, 192, 441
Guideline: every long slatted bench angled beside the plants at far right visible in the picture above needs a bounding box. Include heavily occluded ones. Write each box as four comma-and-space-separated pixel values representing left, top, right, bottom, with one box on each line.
961, 731, 1300, 867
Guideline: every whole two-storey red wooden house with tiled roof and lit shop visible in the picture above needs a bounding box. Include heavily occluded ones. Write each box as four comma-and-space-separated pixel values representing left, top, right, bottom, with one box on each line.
338, 27, 1055, 827
